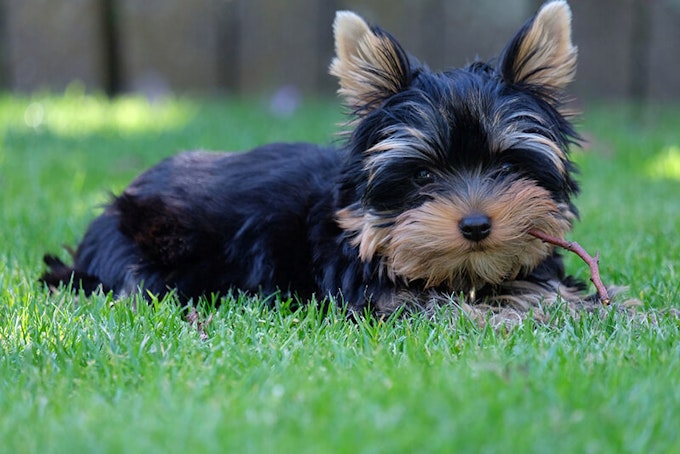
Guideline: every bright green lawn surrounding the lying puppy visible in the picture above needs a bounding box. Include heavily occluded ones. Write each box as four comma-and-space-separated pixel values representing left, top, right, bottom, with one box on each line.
0, 92, 680, 453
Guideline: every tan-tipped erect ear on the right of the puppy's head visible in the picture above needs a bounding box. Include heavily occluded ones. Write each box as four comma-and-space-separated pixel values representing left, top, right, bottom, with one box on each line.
499, 0, 577, 92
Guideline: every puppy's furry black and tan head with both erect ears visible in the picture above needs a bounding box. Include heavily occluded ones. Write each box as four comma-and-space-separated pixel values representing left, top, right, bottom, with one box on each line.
330, 1, 577, 291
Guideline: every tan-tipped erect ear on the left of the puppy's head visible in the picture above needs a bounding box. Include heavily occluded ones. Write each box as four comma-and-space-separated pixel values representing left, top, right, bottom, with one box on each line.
330, 11, 411, 115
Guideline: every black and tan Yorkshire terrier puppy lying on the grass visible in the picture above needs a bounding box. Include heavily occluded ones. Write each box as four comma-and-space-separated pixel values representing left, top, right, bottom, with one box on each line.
42, 1, 587, 315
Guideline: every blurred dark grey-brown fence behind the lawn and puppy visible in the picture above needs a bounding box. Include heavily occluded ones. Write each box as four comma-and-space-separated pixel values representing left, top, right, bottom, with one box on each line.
0, 0, 680, 99
